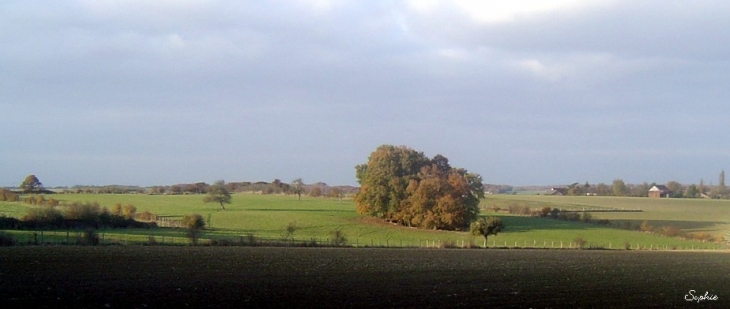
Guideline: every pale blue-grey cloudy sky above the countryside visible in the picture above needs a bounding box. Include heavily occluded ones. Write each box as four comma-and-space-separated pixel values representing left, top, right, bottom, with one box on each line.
0, 0, 730, 186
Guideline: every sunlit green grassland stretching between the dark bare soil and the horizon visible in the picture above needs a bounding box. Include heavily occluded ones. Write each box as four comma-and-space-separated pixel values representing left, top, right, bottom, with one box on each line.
0, 194, 730, 249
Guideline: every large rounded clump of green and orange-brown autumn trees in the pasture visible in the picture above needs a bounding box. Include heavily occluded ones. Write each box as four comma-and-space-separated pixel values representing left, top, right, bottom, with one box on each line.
355, 145, 484, 230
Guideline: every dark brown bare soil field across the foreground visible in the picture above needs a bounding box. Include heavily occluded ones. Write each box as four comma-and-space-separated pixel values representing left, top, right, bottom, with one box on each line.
0, 246, 730, 308
